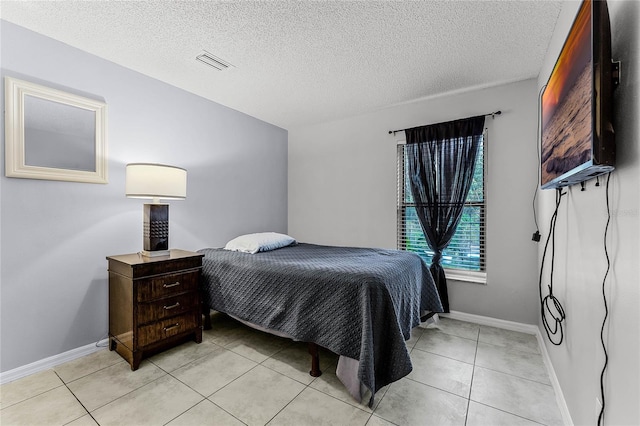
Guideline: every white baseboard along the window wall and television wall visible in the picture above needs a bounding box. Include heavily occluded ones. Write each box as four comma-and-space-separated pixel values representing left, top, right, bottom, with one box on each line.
438, 311, 573, 426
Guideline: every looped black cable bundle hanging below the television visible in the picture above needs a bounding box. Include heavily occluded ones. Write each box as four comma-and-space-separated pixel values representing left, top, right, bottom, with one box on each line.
538, 188, 566, 346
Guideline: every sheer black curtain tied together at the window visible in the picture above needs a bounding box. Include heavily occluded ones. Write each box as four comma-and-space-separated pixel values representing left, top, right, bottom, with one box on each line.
405, 116, 484, 312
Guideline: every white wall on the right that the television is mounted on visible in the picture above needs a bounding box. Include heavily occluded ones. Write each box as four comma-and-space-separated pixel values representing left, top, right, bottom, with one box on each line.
538, 0, 640, 425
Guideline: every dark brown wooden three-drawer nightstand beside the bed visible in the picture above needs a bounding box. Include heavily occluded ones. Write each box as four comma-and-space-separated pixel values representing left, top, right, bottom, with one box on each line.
107, 250, 204, 370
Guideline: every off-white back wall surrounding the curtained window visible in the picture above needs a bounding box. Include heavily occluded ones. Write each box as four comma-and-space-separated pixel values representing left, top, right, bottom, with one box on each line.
289, 77, 538, 324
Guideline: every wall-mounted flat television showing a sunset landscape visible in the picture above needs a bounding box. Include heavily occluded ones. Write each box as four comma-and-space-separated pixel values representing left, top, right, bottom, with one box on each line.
540, 0, 619, 189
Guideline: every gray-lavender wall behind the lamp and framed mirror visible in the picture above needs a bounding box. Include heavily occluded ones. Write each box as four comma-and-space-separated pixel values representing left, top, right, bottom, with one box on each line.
0, 21, 287, 371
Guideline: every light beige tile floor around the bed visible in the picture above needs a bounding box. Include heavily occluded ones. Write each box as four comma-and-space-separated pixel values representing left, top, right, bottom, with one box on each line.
0, 313, 562, 426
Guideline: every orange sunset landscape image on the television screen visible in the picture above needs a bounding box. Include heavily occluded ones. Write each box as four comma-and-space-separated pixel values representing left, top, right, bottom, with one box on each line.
540, 1, 593, 185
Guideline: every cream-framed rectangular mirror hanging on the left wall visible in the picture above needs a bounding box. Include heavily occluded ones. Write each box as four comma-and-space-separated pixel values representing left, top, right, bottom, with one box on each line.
5, 77, 108, 183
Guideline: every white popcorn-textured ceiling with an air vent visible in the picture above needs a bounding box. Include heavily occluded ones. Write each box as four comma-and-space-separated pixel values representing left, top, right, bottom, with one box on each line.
0, 0, 562, 129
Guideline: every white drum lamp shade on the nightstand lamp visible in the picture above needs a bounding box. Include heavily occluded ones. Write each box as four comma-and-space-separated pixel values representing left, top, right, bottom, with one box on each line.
125, 163, 187, 200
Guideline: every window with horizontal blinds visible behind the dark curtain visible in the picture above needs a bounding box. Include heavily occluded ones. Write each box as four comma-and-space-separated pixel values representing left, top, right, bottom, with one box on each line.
397, 137, 486, 282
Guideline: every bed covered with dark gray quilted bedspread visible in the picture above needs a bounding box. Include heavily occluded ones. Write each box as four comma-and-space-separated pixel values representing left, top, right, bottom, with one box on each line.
199, 238, 442, 405
